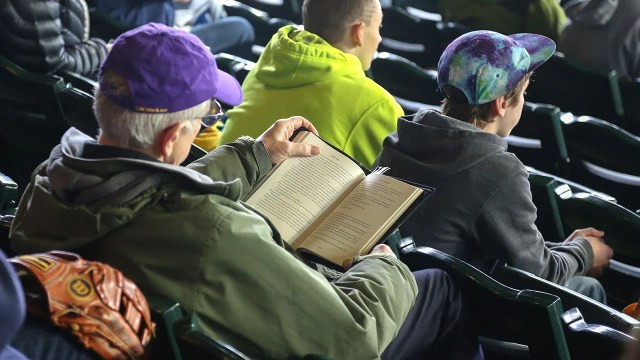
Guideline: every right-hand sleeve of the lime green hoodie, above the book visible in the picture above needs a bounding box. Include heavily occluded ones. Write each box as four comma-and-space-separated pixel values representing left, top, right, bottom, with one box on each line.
344, 95, 404, 169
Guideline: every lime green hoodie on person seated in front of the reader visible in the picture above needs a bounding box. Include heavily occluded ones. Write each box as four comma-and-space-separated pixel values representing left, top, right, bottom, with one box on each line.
220, 25, 403, 167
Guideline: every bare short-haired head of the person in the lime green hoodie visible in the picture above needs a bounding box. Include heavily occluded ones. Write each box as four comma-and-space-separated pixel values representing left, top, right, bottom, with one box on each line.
302, 0, 382, 70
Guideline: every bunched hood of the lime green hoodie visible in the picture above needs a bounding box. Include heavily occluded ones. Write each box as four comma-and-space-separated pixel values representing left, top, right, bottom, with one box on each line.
256, 25, 364, 88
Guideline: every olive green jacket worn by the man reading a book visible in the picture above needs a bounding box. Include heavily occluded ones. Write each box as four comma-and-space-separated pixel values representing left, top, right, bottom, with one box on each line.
10, 129, 417, 359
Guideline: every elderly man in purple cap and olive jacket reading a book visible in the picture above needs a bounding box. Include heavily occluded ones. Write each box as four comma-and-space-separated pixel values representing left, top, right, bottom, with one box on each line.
11, 24, 482, 359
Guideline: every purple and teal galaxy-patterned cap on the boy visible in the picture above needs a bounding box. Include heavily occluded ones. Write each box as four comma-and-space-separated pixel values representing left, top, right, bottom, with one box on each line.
438, 30, 556, 105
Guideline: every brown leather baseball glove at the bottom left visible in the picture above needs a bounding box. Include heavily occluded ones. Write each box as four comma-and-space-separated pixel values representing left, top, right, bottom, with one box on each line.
10, 251, 155, 359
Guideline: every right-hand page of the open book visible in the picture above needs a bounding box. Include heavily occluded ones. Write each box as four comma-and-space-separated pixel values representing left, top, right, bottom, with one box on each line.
300, 173, 423, 264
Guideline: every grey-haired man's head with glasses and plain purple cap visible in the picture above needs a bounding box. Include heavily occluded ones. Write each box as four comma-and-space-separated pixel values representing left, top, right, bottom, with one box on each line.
94, 23, 242, 164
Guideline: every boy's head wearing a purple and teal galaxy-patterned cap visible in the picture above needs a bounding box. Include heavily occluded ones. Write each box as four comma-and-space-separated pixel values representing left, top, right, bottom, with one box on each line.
438, 30, 556, 137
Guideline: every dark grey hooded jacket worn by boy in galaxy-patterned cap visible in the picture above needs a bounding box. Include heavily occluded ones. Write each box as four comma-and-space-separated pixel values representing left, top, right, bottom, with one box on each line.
378, 110, 593, 284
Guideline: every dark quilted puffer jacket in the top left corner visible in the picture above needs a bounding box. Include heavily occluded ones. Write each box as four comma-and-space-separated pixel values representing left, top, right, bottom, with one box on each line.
0, 0, 107, 75
